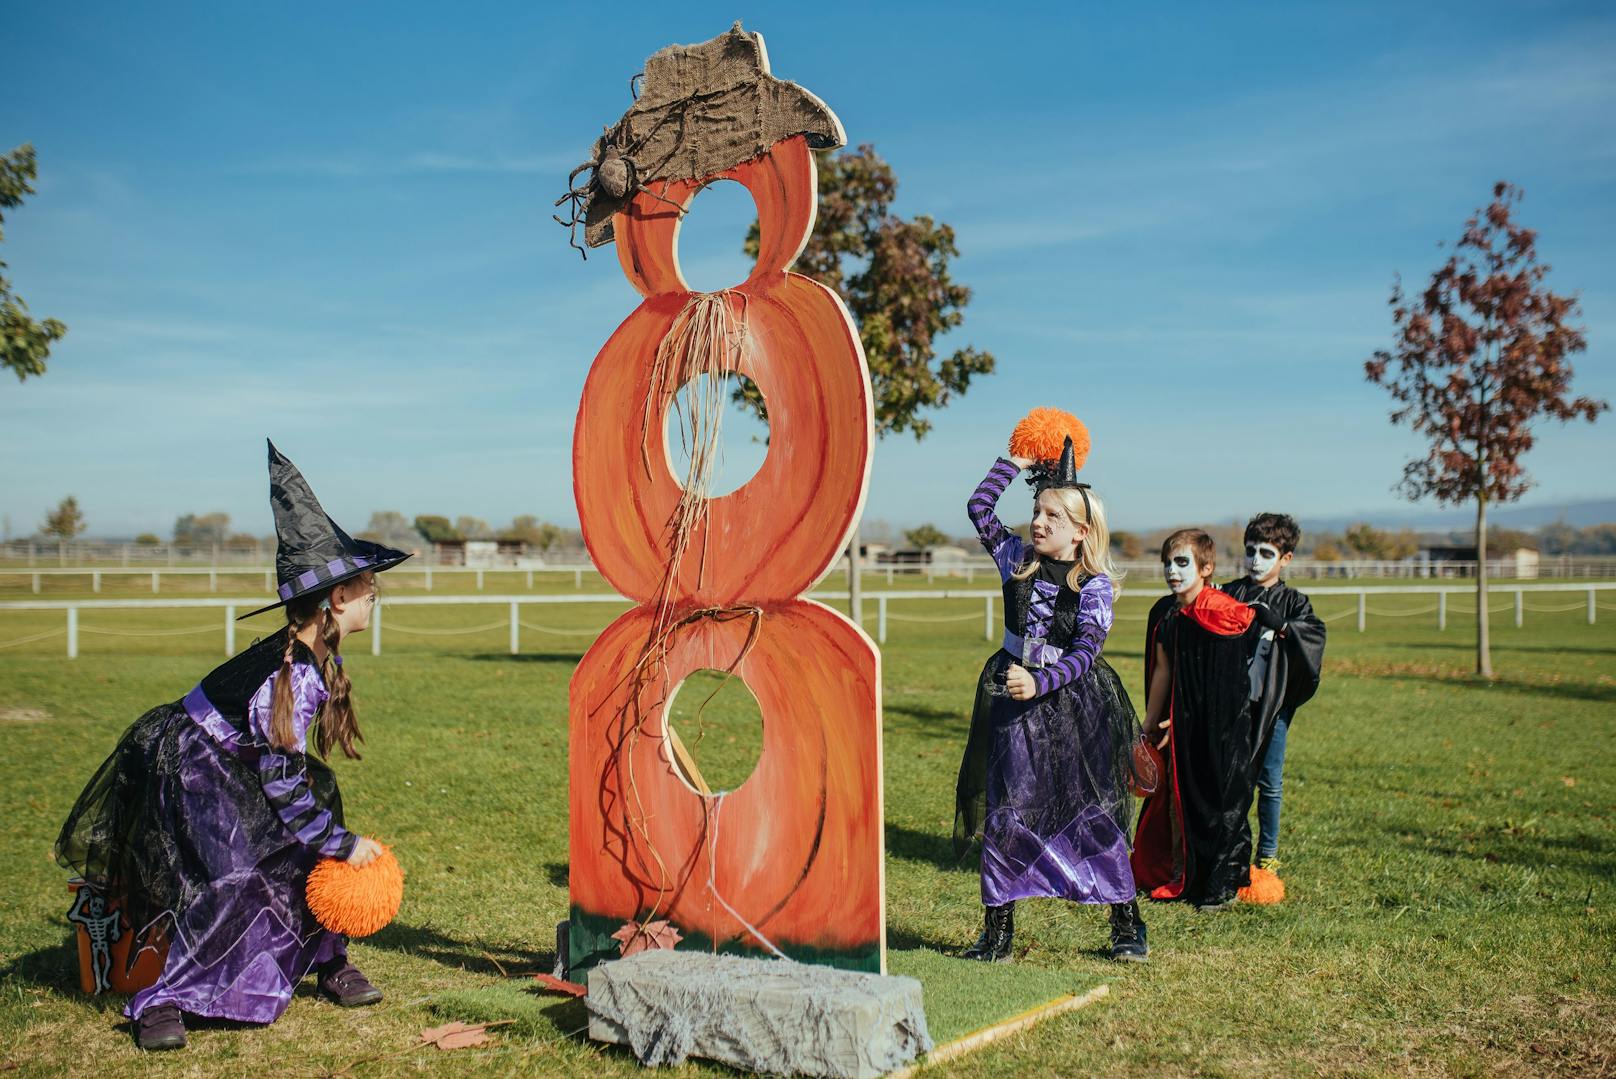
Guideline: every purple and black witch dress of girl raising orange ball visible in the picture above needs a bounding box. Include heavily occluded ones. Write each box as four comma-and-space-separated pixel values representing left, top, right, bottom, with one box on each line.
953, 457, 1139, 906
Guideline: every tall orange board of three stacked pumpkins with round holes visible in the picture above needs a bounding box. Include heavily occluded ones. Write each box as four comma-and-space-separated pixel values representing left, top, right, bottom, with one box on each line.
567, 42, 886, 980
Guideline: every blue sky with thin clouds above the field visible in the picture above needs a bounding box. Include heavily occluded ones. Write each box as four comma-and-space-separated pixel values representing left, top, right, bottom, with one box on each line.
0, 0, 1616, 535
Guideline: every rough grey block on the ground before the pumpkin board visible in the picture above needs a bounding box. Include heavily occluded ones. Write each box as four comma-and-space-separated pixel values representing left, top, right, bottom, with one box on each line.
585, 950, 931, 1079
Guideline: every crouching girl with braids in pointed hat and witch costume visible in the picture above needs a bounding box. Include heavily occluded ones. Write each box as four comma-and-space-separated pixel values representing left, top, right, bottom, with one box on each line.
55, 444, 409, 1050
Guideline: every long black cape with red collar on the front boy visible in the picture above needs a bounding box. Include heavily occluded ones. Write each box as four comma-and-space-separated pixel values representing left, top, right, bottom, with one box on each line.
1133, 586, 1260, 903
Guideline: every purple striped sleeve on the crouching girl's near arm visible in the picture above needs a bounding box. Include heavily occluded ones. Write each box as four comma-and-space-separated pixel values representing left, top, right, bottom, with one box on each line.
247, 664, 359, 858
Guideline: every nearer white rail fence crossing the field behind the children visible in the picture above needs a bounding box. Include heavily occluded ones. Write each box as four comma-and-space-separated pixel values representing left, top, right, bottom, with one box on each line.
0, 583, 1616, 659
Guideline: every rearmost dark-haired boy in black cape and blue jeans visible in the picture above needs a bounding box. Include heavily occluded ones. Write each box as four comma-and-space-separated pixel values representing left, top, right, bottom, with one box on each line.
1223, 514, 1325, 871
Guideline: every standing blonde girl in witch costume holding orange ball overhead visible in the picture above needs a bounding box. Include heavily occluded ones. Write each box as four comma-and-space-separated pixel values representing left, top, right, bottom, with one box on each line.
953, 409, 1149, 963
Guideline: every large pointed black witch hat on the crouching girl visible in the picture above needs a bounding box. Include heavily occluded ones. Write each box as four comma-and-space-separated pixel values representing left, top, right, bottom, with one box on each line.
238, 439, 409, 620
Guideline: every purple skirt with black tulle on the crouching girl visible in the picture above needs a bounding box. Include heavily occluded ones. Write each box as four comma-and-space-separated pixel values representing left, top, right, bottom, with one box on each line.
55, 703, 343, 1022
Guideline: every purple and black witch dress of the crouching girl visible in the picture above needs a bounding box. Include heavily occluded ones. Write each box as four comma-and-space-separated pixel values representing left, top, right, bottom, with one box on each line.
57, 630, 357, 1022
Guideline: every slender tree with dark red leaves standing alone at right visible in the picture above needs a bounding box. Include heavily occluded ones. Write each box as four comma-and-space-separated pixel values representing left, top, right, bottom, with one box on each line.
1364, 183, 1610, 678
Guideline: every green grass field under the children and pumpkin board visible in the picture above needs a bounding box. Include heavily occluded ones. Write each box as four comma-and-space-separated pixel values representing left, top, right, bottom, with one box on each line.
0, 581, 1616, 1076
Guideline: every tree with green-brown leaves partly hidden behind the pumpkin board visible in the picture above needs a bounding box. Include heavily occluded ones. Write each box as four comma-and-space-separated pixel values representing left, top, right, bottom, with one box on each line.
734, 144, 994, 619
